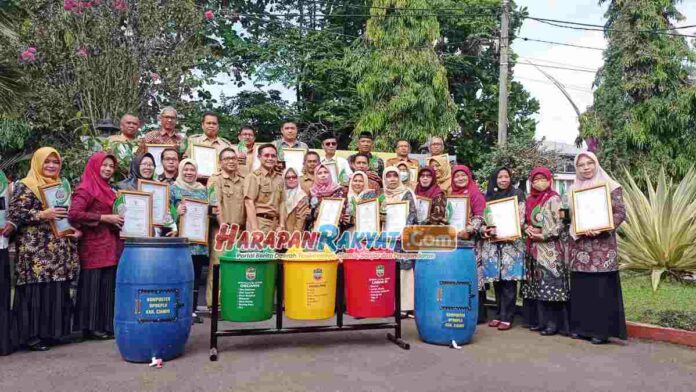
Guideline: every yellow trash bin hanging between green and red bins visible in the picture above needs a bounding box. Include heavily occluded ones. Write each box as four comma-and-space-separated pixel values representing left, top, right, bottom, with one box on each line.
283, 248, 338, 320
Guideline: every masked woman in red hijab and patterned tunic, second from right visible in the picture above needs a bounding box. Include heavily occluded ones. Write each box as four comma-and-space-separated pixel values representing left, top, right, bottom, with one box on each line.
521, 167, 569, 336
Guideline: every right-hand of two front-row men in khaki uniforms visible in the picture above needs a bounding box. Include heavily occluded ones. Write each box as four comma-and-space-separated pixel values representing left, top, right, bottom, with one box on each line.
244, 144, 286, 234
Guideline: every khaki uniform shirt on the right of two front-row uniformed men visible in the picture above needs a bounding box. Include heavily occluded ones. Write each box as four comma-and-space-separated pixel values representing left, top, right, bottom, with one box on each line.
244, 167, 285, 218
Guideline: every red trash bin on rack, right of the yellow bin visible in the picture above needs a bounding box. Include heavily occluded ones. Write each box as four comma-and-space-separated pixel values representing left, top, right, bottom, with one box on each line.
343, 249, 396, 318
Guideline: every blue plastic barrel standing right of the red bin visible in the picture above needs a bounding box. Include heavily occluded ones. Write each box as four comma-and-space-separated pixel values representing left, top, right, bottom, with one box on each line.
415, 241, 478, 345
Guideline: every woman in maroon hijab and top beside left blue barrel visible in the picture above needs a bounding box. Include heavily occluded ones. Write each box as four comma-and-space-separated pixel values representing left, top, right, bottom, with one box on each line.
68, 152, 123, 340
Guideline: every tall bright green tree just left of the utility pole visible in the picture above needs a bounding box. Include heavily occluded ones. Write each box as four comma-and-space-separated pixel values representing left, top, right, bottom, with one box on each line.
348, 0, 457, 150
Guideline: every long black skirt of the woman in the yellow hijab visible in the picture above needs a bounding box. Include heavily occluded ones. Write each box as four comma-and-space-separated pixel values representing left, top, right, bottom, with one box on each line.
13, 281, 72, 345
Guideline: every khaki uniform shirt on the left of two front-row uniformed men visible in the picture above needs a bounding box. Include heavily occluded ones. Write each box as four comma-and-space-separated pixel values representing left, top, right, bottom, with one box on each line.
207, 171, 246, 227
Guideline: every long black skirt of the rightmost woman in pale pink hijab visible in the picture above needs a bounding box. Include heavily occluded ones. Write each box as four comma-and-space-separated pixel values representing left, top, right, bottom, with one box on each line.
570, 271, 627, 340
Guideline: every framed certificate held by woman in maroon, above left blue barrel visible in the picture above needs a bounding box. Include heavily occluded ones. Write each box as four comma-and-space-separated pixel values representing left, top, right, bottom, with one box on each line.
114, 191, 152, 238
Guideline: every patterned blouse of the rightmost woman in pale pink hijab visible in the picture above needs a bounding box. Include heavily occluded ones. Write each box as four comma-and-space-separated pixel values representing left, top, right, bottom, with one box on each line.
568, 188, 626, 272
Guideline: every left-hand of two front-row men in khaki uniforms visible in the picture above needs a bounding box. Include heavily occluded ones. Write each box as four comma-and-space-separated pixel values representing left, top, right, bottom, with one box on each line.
205, 148, 246, 307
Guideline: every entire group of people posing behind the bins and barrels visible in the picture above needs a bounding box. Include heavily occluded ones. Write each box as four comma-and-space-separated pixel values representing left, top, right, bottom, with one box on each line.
0, 108, 626, 354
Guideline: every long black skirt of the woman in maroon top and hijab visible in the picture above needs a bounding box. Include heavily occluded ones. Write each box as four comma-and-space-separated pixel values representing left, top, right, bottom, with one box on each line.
73, 266, 116, 334
